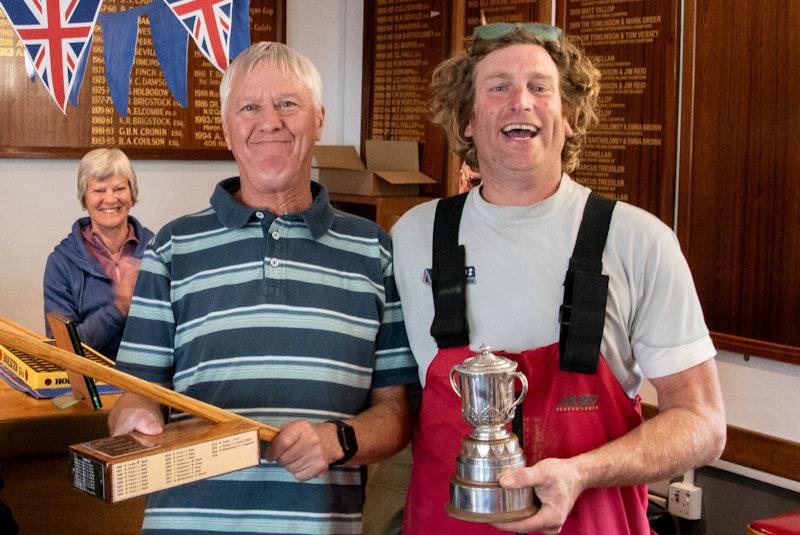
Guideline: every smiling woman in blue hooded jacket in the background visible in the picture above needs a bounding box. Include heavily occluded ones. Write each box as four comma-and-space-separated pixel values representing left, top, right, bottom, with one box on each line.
44, 149, 153, 359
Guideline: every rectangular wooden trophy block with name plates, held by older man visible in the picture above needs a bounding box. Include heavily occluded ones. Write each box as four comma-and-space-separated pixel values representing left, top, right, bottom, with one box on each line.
69, 418, 260, 503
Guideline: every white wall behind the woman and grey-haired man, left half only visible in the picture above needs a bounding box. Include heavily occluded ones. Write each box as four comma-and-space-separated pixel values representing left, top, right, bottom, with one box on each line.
0, 0, 363, 331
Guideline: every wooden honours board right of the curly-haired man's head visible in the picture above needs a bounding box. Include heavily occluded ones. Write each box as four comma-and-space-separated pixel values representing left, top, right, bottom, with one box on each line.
556, 0, 680, 226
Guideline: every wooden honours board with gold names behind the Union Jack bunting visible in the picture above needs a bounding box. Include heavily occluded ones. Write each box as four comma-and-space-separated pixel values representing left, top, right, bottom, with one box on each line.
0, 0, 286, 159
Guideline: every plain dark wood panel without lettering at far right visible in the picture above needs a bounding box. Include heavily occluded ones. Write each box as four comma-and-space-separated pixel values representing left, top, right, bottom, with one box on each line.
677, 0, 800, 363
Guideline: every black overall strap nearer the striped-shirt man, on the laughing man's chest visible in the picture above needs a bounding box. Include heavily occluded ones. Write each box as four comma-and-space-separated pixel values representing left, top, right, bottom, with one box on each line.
431, 193, 469, 347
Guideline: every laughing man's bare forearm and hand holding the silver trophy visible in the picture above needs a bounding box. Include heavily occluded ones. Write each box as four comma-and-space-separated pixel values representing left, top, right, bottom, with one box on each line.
498, 360, 725, 533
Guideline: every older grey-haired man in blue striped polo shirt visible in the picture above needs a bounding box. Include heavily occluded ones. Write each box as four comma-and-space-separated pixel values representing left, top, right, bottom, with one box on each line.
110, 43, 416, 534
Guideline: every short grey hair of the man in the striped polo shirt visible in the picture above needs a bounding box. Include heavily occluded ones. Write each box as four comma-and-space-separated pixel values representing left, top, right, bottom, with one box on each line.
219, 41, 322, 118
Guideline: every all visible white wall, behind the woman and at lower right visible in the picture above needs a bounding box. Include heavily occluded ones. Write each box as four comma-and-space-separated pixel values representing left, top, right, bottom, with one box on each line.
0, 0, 800, 489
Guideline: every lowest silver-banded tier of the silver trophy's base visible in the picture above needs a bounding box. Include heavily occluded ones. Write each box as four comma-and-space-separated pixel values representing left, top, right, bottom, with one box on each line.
445, 476, 539, 523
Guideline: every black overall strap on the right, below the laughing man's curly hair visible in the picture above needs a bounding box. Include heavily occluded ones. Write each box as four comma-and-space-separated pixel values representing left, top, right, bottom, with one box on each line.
559, 193, 616, 374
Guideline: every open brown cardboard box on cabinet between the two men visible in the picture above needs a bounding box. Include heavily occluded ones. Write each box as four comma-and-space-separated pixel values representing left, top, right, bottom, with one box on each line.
311, 139, 436, 196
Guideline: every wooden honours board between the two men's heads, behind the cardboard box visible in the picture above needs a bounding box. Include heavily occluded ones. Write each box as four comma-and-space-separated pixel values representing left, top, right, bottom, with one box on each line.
361, 0, 451, 195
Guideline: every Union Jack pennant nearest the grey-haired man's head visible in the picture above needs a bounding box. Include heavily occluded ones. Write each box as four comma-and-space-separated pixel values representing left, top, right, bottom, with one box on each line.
164, 0, 233, 72
